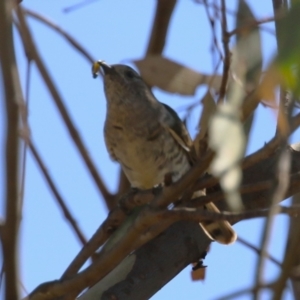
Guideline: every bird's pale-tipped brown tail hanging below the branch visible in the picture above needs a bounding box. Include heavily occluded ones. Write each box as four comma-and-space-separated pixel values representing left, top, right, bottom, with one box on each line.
200, 202, 237, 245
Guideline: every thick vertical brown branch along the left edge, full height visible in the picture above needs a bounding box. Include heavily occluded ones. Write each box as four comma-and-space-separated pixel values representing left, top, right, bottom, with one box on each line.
0, 1, 22, 300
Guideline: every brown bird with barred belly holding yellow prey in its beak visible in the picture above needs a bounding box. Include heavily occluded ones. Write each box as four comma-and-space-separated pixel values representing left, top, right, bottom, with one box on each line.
92, 60, 237, 245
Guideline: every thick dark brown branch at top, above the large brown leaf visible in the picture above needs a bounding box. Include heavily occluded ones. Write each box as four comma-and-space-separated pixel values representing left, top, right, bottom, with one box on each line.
146, 0, 176, 56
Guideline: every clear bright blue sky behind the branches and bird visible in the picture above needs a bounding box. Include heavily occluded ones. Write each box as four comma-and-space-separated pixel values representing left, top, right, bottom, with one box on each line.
0, 0, 300, 300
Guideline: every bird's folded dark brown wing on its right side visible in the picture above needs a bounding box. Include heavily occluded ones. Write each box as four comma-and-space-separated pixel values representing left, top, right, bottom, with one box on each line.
162, 103, 197, 164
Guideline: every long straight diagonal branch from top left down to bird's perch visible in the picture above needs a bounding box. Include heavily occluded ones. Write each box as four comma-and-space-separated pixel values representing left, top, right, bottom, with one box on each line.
16, 7, 114, 210
